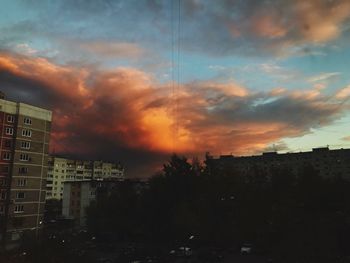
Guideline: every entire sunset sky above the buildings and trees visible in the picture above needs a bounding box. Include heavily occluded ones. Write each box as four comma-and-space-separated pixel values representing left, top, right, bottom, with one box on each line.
0, 0, 350, 177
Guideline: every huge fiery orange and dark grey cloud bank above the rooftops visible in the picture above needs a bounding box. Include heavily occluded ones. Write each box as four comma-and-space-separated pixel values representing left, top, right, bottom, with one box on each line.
0, 53, 346, 175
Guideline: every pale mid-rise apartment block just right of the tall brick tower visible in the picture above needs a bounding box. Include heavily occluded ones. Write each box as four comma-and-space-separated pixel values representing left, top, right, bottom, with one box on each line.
46, 156, 124, 199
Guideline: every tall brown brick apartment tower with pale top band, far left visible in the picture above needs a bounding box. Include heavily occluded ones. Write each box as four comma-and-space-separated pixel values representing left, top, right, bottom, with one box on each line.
0, 96, 52, 244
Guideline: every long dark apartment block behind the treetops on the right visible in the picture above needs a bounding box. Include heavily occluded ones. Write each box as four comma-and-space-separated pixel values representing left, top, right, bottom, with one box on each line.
209, 147, 350, 180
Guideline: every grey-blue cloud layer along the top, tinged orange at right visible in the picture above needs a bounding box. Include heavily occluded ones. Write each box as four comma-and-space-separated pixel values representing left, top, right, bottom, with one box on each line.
0, 0, 350, 59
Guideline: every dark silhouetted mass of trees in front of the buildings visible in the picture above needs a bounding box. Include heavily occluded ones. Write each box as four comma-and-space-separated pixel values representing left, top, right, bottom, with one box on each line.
87, 155, 350, 259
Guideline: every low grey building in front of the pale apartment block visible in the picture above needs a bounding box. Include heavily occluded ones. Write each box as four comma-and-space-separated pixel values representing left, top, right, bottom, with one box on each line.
62, 179, 148, 227
